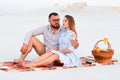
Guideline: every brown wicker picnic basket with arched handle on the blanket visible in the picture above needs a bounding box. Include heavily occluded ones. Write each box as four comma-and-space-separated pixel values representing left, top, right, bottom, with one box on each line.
92, 40, 114, 63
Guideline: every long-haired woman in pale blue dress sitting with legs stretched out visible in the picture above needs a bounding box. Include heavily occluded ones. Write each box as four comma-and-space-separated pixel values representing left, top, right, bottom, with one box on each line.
26, 15, 81, 67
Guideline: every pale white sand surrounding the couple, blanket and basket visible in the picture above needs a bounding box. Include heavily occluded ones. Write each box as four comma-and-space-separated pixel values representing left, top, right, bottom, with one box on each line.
0, 1, 120, 80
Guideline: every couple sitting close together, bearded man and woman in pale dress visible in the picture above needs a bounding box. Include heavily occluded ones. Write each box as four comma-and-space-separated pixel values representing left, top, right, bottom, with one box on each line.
18, 12, 81, 67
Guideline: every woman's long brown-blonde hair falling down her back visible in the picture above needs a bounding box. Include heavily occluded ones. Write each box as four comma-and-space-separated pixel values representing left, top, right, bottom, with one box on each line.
65, 15, 77, 34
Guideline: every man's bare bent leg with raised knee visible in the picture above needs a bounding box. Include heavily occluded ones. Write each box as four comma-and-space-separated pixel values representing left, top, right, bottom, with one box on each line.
19, 37, 45, 61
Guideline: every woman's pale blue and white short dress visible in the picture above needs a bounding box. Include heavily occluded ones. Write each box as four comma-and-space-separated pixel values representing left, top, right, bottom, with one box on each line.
51, 30, 81, 67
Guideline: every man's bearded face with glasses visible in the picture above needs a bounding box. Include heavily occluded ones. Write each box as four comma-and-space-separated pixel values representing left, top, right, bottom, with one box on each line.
49, 15, 60, 28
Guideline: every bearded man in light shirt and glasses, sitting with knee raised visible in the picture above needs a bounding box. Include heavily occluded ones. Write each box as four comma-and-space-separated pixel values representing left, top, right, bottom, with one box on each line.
19, 12, 79, 61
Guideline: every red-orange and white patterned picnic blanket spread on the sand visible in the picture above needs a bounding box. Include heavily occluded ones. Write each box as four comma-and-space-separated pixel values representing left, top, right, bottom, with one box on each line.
0, 56, 120, 72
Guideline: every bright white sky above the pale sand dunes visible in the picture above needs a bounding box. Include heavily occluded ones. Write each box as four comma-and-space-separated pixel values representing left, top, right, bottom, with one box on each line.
0, 0, 120, 14
